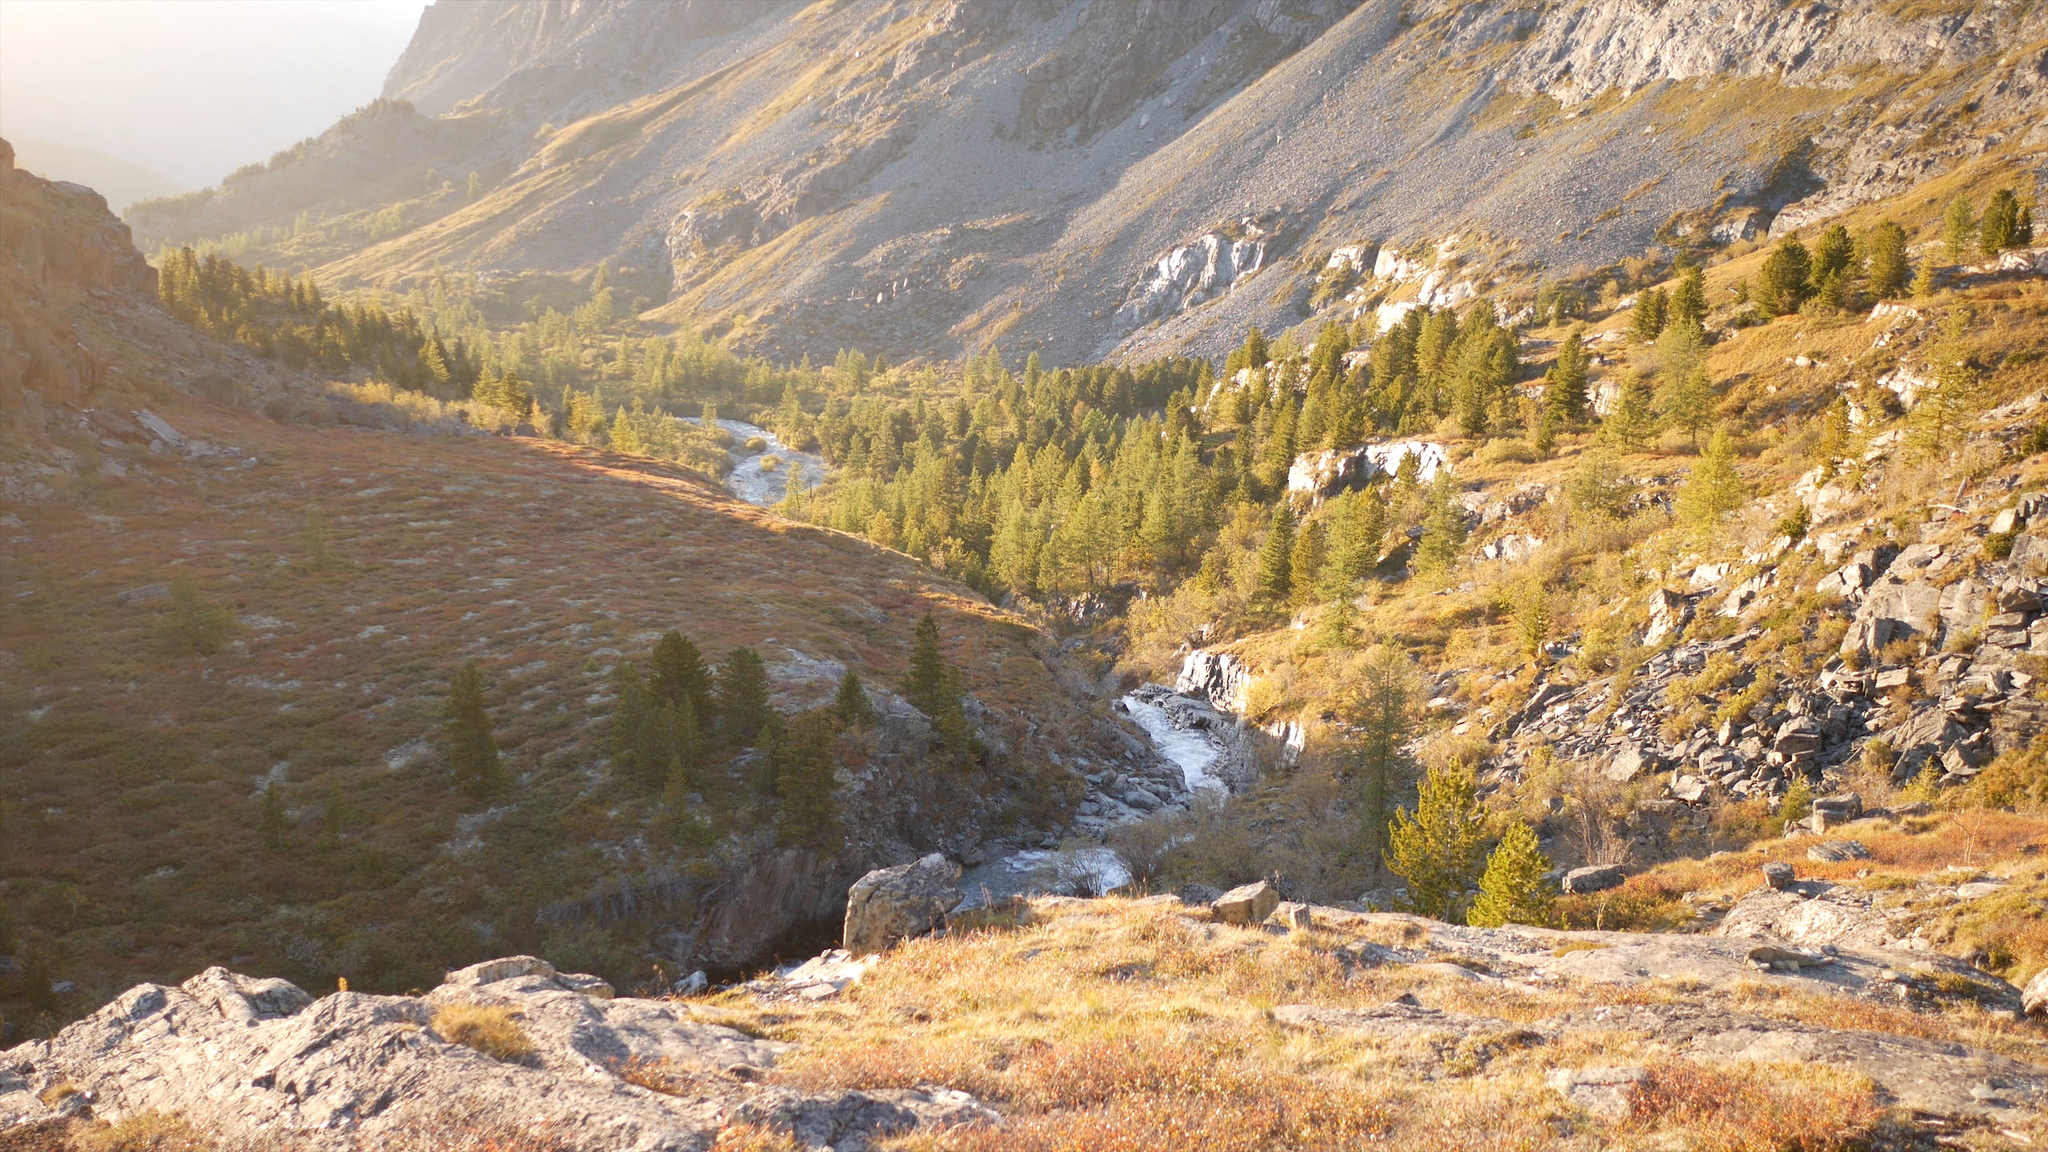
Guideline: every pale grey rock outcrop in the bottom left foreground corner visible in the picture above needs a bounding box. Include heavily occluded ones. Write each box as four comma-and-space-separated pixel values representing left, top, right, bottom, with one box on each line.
0, 955, 995, 1152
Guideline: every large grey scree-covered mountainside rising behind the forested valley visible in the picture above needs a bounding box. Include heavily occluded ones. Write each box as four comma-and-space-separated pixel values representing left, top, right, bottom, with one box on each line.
131, 0, 2048, 363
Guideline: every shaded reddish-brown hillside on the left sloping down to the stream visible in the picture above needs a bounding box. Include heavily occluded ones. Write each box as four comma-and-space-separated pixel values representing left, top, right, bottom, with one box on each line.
0, 139, 1178, 1029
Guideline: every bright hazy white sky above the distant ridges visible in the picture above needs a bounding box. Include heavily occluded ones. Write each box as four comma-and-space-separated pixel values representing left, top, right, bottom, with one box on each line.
0, 0, 426, 189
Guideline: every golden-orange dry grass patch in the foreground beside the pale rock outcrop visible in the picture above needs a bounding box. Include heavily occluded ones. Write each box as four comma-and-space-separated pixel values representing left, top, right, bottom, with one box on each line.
671, 900, 1911, 1152
